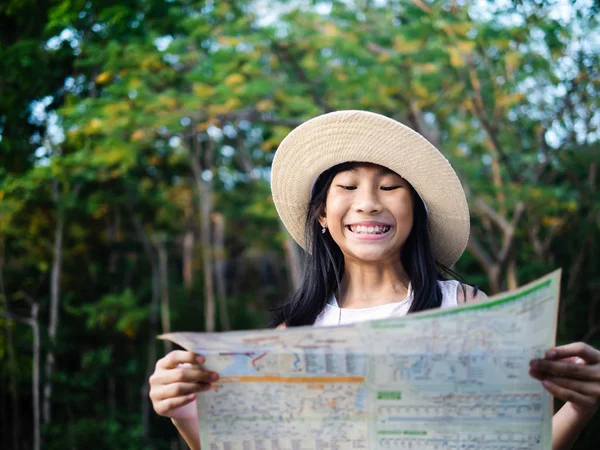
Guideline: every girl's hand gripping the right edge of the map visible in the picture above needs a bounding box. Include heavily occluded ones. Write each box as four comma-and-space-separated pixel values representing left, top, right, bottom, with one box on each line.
529, 342, 600, 416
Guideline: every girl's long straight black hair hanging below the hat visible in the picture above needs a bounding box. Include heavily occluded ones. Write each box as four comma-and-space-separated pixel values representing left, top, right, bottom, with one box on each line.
271, 162, 464, 327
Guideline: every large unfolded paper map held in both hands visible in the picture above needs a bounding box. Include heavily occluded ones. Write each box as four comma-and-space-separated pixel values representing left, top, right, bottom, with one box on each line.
161, 271, 560, 450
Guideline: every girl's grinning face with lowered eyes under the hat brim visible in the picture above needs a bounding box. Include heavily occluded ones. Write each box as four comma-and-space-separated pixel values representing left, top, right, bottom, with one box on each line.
319, 164, 413, 263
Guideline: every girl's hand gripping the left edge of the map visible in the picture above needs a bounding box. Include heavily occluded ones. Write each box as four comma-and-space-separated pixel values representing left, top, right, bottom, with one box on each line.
150, 350, 219, 420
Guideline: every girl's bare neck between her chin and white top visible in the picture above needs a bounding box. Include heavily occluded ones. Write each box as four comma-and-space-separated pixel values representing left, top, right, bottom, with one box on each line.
338, 261, 410, 308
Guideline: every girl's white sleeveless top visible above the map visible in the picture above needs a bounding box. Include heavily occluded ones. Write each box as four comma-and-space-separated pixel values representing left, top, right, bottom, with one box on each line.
315, 280, 459, 327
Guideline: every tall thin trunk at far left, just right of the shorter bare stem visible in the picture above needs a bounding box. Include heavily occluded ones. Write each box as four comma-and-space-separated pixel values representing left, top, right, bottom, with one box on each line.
43, 180, 64, 425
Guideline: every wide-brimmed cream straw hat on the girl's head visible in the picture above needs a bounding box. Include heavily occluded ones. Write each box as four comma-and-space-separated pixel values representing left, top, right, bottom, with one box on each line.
271, 111, 469, 266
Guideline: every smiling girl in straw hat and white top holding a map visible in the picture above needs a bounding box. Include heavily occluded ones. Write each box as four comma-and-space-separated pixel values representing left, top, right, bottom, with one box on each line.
150, 111, 600, 450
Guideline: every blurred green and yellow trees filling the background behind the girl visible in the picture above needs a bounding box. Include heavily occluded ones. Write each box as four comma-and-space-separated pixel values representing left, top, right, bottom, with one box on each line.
0, 0, 600, 449
